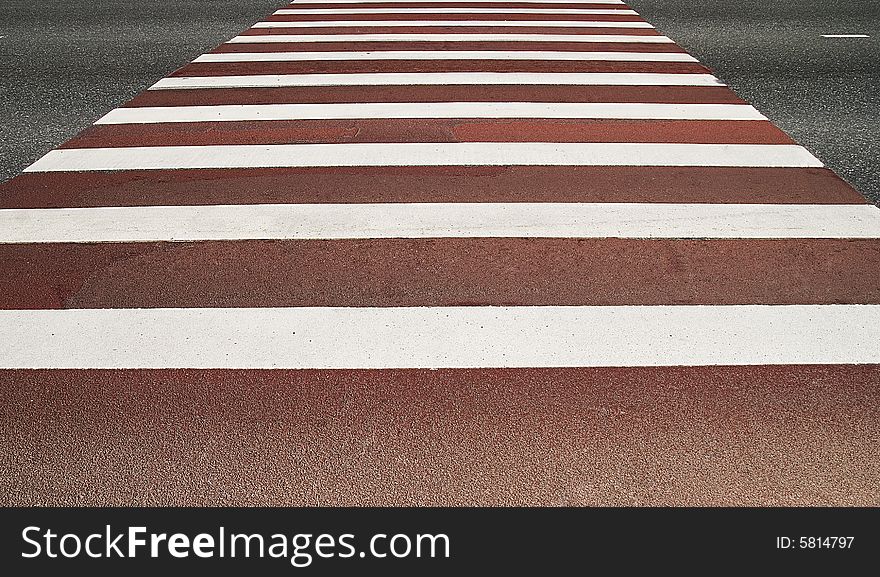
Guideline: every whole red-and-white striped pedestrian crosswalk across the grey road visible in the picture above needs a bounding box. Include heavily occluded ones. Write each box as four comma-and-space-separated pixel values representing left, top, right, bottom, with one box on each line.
0, 0, 880, 505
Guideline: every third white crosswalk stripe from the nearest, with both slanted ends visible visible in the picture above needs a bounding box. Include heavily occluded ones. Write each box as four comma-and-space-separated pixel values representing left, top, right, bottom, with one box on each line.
25, 142, 822, 172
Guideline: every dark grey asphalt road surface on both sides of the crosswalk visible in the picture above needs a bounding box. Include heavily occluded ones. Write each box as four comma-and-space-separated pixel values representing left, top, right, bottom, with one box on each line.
0, 0, 880, 203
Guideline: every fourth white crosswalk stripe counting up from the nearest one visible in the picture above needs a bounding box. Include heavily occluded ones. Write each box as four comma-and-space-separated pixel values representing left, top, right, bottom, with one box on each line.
95, 102, 766, 124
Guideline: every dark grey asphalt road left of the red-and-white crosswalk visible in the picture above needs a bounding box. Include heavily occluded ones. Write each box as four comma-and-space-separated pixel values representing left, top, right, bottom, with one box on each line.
0, 0, 287, 180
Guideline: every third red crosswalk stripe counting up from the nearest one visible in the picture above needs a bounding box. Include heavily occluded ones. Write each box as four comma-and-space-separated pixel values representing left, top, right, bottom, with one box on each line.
0, 166, 866, 208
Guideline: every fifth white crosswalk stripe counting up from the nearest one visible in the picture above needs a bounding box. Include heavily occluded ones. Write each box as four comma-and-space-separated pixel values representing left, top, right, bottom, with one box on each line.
150, 72, 724, 90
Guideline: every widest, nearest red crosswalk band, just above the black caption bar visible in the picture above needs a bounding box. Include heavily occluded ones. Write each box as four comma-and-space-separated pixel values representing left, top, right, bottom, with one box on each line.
0, 365, 880, 504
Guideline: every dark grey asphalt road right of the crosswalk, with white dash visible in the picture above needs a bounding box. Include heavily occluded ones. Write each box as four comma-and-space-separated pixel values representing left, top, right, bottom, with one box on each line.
628, 0, 880, 204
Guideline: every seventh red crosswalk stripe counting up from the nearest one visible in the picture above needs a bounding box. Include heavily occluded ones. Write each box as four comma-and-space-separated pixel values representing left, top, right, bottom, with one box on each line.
211, 41, 685, 54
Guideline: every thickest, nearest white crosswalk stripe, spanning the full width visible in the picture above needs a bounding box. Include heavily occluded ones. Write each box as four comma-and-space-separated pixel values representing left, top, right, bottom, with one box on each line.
0, 305, 880, 369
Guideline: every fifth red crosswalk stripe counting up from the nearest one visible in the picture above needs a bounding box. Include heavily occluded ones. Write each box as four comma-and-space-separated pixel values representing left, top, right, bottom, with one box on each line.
124, 85, 744, 107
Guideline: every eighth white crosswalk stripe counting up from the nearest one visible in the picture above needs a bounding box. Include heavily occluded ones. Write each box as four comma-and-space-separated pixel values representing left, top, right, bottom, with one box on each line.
253, 20, 653, 28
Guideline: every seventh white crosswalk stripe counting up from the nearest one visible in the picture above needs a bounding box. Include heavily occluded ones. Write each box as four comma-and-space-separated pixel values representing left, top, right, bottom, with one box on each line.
227, 34, 672, 44
